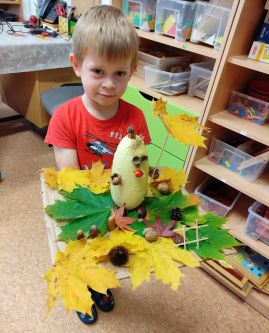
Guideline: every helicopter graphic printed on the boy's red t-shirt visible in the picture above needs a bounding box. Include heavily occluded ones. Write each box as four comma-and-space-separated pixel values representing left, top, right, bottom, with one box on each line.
84, 131, 118, 158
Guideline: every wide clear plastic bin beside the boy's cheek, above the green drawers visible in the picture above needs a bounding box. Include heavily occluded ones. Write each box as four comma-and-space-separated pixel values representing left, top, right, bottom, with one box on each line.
144, 65, 190, 95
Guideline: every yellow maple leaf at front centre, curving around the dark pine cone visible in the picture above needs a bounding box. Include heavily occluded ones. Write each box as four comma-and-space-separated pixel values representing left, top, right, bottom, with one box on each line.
87, 229, 199, 289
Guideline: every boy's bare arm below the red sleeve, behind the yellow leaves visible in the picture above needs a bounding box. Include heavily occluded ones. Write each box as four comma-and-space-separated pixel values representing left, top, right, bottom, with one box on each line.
53, 146, 80, 170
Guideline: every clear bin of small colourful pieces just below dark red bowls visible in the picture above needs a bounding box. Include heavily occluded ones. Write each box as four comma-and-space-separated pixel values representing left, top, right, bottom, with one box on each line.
228, 91, 269, 125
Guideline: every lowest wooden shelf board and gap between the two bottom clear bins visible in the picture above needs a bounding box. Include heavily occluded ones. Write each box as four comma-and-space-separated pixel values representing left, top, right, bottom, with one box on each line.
225, 195, 269, 259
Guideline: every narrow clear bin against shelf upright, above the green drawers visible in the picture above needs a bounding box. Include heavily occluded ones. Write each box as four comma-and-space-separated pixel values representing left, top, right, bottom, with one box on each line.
188, 61, 214, 99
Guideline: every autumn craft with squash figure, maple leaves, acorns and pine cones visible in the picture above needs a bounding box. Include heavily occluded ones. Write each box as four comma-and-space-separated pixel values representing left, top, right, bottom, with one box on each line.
42, 100, 239, 314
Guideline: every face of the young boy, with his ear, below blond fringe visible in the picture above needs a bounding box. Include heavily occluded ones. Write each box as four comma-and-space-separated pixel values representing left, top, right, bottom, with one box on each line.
70, 52, 132, 107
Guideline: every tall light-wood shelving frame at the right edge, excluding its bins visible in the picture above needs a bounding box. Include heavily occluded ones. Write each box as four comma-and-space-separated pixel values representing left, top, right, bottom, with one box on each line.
186, 0, 269, 318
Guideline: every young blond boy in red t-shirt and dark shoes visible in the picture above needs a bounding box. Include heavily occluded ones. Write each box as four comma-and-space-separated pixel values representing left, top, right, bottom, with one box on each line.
45, 5, 150, 324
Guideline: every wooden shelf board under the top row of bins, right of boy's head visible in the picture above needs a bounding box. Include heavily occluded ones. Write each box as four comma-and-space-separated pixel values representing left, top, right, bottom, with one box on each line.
137, 29, 219, 59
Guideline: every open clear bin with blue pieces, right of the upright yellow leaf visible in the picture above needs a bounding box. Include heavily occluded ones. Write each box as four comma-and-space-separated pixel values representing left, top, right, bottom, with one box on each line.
208, 133, 267, 182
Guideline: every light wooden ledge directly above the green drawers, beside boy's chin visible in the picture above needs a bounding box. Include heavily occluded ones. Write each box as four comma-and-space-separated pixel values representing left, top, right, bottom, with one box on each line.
130, 75, 204, 117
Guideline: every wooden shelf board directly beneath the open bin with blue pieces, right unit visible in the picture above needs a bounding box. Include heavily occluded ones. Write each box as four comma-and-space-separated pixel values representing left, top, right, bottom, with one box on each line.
194, 156, 269, 206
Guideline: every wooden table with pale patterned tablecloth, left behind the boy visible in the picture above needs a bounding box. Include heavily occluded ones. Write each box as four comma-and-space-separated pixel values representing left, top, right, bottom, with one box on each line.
0, 22, 79, 128
